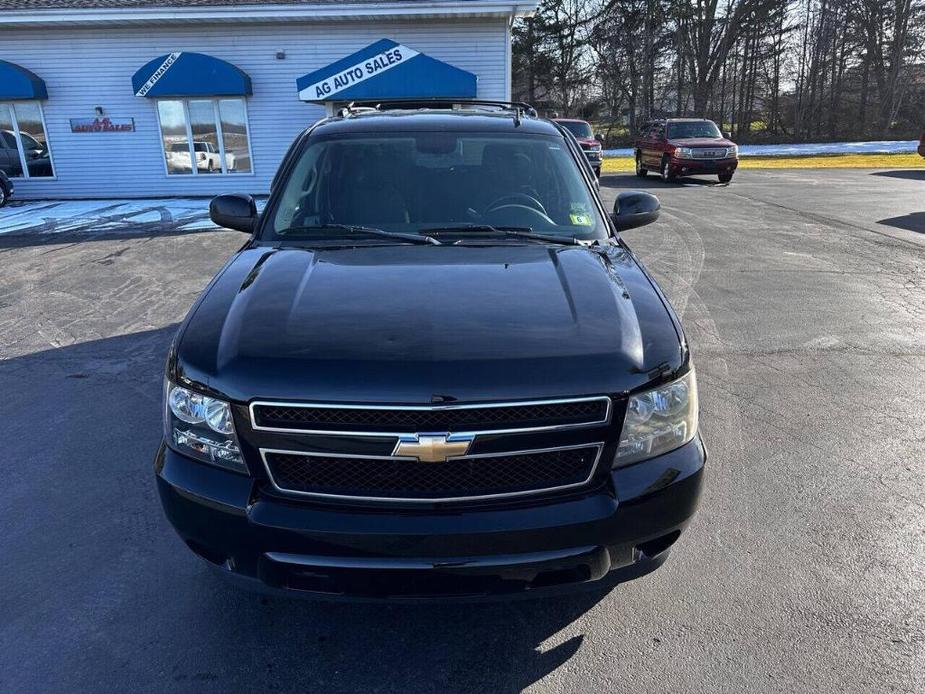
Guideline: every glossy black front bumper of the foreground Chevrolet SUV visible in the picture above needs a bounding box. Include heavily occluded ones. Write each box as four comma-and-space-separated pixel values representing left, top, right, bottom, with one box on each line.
155, 436, 706, 599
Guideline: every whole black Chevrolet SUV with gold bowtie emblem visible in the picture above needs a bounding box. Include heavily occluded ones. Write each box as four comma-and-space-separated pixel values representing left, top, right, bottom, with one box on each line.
155, 102, 705, 599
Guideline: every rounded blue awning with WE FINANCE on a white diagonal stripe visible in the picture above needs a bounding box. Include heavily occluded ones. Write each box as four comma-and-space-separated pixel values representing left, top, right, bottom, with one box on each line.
132, 51, 252, 97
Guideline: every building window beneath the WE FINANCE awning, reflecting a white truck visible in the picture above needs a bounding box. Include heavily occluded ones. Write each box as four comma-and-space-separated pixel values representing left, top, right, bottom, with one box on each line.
157, 99, 251, 176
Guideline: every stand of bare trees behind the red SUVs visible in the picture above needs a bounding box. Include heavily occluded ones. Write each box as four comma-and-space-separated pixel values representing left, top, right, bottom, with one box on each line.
514, 0, 925, 140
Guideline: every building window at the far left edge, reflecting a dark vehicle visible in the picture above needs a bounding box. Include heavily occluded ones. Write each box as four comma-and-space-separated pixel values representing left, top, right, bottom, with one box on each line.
0, 101, 55, 178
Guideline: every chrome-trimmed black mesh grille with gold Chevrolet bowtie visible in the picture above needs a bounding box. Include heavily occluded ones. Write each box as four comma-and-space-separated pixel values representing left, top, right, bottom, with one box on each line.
249, 396, 612, 502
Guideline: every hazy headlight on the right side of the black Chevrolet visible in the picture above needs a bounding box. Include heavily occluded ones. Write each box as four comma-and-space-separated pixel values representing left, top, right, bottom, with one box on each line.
614, 369, 698, 467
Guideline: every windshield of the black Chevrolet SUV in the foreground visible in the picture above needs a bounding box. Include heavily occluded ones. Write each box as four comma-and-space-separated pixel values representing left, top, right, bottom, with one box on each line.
265, 132, 608, 240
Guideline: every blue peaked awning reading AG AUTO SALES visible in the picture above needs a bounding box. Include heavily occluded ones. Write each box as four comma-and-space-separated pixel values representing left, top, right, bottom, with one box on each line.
296, 39, 478, 102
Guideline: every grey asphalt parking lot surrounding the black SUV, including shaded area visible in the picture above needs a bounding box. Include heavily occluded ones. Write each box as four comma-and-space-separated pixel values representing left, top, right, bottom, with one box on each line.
0, 169, 925, 694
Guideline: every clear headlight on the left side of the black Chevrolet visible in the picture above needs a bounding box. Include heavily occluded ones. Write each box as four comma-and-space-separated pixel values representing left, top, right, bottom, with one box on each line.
164, 381, 247, 474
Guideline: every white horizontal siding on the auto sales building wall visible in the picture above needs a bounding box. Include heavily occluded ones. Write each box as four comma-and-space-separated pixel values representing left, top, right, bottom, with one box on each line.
0, 19, 510, 199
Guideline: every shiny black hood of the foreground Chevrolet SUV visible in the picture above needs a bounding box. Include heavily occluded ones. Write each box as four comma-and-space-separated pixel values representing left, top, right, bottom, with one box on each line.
176, 244, 684, 404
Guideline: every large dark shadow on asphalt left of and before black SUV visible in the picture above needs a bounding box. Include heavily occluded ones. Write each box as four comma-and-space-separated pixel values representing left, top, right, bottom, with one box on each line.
0, 324, 619, 694
